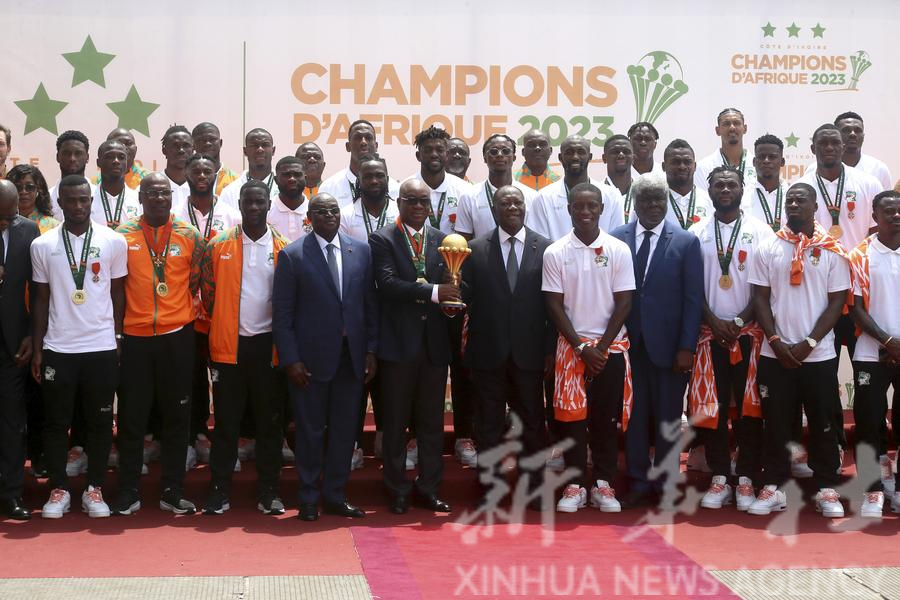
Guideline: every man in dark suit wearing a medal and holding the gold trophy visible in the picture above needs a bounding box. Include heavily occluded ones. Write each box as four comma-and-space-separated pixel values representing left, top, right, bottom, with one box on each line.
369, 179, 462, 514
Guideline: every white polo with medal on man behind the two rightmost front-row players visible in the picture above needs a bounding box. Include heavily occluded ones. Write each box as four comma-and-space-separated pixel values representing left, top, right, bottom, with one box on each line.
797, 165, 882, 252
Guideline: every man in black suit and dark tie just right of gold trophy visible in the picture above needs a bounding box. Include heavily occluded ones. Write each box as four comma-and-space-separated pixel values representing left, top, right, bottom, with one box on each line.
463, 185, 554, 508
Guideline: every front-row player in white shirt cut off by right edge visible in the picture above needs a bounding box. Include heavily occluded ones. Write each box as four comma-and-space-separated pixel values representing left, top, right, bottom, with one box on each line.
850, 190, 900, 518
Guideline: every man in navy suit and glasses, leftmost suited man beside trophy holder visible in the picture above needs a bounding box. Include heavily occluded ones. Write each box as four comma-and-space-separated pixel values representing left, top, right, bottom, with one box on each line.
272, 194, 378, 521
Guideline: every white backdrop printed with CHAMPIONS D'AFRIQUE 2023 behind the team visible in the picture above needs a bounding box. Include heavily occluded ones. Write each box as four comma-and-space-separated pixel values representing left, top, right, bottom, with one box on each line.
0, 0, 900, 184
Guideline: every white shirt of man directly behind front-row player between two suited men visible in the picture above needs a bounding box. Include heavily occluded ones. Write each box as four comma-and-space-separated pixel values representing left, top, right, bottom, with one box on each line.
525, 179, 633, 240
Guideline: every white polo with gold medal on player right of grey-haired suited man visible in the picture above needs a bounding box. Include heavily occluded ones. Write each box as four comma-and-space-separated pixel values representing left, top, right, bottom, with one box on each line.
690, 213, 775, 321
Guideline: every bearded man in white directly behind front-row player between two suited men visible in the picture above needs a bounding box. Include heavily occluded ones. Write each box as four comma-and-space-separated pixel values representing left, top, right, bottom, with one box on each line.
528, 135, 625, 241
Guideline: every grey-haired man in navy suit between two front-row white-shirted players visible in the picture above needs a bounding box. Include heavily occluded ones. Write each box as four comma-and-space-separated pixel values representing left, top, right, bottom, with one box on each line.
612, 174, 703, 508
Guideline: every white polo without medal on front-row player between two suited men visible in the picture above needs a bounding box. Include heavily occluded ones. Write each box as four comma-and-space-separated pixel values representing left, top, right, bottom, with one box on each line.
541, 229, 635, 340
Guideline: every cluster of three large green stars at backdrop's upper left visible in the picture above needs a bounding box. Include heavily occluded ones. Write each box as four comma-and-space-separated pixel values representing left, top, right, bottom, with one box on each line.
15, 36, 159, 136
